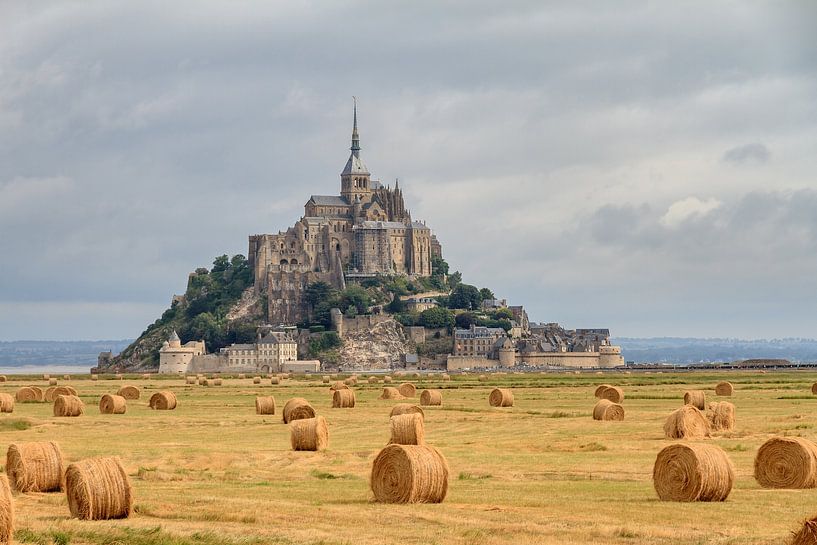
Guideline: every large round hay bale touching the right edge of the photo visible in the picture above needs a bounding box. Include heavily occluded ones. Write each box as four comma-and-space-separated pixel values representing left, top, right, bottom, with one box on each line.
755, 437, 817, 488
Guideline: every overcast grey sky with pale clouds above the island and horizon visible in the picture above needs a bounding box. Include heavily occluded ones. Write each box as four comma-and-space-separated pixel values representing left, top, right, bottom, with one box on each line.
0, 0, 817, 340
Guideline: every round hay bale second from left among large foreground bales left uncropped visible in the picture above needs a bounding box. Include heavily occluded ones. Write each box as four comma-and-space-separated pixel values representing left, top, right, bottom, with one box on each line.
65, 458, 133, 520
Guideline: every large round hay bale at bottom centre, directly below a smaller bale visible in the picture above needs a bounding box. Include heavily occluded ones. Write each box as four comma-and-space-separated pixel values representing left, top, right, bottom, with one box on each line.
370, 445, 449, 503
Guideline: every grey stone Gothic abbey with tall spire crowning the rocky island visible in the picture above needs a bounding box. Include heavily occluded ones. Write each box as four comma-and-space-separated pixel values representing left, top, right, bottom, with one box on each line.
247, 107, 442, 324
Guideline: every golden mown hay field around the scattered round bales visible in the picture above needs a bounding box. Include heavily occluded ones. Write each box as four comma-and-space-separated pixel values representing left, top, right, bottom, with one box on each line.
0, 372, 817, 545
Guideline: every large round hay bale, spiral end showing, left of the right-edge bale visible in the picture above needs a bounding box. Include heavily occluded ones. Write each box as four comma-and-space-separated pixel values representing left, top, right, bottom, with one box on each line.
652, 443, 735, 501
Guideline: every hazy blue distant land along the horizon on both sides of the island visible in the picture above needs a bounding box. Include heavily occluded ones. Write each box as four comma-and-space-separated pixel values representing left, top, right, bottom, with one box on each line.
0, 337, 817, 367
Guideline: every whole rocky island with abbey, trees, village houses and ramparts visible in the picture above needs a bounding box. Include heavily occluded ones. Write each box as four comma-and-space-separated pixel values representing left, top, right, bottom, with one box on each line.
103, 108, 624, 373
